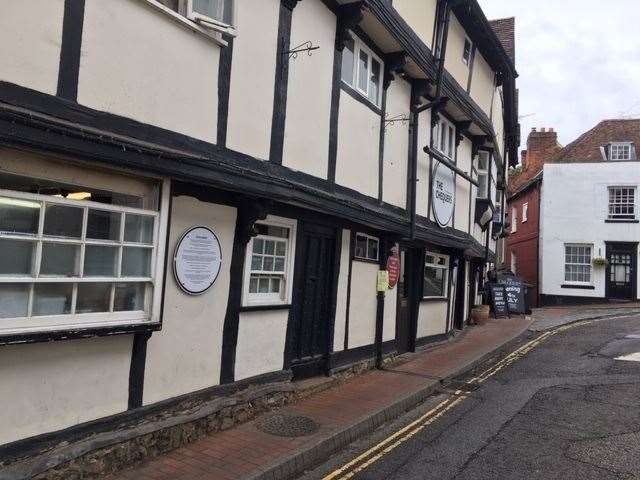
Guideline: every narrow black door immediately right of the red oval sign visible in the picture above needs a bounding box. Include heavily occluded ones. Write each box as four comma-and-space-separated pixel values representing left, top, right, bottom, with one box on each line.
396, 247, 414, 353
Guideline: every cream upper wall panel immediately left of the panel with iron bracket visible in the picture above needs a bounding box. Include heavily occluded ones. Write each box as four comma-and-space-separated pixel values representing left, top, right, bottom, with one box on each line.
227, 0, 282, 159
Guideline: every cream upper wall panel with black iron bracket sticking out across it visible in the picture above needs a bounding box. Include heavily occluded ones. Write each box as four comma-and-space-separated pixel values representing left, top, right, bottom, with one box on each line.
282, 0, 336, 178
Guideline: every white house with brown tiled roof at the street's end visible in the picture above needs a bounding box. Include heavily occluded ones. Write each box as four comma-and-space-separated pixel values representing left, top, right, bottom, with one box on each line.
539, 120, 640, 303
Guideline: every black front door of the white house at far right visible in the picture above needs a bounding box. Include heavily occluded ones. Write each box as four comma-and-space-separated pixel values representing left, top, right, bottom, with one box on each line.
606, 243, 637, 300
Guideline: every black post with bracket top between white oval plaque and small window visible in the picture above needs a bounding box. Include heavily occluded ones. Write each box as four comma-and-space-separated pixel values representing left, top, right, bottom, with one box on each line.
220, 200, 271, 384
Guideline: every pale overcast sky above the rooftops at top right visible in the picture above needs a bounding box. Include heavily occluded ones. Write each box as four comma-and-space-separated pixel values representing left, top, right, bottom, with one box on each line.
479, 0, 640, 148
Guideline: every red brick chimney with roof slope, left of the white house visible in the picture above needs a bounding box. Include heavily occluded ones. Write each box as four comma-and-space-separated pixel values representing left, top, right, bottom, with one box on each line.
509, 127, 562, 192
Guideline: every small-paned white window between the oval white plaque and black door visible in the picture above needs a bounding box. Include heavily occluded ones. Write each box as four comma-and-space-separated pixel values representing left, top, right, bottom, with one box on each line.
242, 215, 298, 307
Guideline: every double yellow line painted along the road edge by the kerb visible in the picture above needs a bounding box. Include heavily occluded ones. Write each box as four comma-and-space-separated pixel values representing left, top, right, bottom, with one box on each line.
322, 321, 591, 480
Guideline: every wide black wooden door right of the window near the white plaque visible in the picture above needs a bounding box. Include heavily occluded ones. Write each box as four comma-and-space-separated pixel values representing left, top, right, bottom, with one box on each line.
290, 223, 336, 379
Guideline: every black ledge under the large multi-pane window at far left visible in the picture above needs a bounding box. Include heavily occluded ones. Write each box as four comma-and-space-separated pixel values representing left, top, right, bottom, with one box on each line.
0, 322, 162, 345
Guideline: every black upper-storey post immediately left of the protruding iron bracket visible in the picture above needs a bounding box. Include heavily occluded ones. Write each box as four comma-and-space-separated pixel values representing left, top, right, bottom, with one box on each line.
269, 0, 300, 165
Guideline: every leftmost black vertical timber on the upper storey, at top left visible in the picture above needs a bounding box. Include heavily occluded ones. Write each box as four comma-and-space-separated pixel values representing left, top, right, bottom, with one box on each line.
57, 0, 85, 102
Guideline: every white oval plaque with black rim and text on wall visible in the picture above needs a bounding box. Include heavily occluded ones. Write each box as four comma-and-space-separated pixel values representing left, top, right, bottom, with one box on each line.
173, 227, 222, 295
